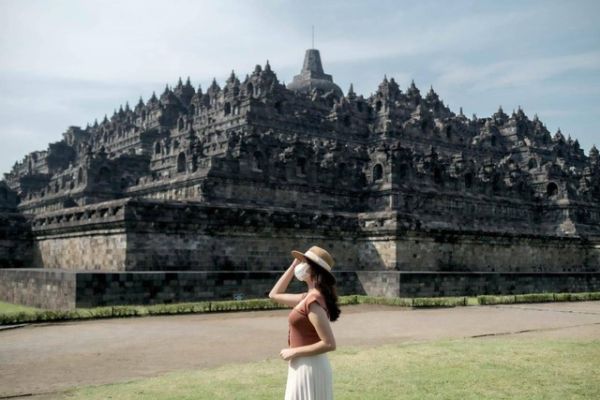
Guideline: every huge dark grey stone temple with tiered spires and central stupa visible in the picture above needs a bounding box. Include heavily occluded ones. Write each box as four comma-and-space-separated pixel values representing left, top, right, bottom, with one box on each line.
0, 49, 600, 308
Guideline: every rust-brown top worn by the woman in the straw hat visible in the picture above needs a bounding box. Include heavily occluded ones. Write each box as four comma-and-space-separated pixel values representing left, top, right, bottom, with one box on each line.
288, 291, 329, 347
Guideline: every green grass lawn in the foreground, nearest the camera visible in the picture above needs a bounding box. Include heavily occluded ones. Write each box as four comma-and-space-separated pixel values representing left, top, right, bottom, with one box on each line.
48, 337, 600, 400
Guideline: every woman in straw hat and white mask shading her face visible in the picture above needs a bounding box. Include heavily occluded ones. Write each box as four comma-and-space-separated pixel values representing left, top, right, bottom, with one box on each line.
269, 246, 341, 400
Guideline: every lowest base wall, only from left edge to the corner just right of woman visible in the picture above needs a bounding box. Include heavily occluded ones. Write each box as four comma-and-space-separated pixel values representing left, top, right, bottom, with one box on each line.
0, 268, 363, 309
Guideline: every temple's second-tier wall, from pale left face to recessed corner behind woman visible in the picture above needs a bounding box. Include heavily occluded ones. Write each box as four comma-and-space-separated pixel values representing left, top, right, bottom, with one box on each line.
28, 199, 364, 271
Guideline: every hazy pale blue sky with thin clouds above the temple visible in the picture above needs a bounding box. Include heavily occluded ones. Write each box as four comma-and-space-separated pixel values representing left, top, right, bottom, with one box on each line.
0, 0, 600, 173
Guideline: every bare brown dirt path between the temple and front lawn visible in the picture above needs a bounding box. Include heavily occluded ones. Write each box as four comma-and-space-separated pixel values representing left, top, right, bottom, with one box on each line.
0, 301, 600, 400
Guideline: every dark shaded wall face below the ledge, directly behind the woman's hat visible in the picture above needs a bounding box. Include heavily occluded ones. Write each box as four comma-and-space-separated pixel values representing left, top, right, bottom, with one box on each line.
127, 231, 356, 271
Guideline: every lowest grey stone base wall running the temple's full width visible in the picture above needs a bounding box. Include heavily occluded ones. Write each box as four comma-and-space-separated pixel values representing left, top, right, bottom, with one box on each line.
0, 269, 600, 309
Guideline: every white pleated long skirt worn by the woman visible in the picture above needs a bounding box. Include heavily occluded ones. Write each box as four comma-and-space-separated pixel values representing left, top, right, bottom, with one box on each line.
285, 353, 333, 400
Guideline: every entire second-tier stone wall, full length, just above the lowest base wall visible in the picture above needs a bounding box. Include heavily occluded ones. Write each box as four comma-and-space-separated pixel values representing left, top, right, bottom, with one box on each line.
25, 199, 600, 272
